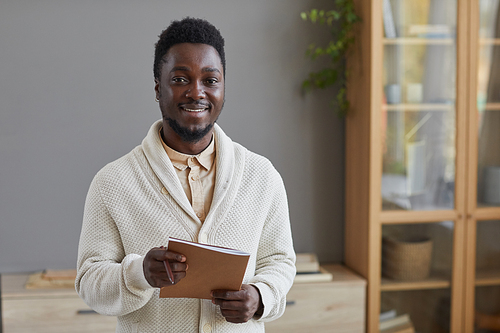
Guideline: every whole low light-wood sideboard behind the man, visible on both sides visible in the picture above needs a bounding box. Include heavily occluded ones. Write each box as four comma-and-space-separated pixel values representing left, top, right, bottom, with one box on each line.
0, 265, 366, 333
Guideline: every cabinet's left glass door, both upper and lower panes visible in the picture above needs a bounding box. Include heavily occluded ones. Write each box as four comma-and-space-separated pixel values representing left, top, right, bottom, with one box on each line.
379, 0, 463, 332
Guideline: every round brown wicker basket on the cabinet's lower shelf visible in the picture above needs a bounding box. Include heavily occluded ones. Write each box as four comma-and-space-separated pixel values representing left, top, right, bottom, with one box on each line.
382, 237, 432, 281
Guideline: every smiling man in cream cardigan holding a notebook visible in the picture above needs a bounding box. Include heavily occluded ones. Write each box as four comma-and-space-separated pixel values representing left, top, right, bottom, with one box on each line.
76, 18, 295, 332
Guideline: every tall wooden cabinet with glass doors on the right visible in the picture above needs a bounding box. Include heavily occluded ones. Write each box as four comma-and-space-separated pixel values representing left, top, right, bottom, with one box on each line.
345, 0, 500, 332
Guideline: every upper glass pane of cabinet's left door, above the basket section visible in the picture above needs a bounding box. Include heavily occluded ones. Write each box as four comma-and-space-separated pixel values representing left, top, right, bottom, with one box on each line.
381, 0, 458, 210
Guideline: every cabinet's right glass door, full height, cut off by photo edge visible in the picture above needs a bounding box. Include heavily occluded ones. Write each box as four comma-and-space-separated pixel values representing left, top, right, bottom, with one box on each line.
471, 0, 500, 333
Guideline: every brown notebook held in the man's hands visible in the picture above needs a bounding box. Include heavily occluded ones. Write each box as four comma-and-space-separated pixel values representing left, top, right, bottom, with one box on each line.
160, 237, 250, 299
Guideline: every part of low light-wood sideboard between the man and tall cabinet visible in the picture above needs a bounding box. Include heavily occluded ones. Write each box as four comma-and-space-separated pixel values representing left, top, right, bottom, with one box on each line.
266, 265, 366, 333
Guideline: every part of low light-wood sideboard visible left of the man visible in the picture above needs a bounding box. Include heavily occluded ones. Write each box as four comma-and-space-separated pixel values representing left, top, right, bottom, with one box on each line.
1, 274, 116, 333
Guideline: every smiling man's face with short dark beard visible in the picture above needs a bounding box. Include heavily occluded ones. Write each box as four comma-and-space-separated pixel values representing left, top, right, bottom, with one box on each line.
155, 43, 224, 145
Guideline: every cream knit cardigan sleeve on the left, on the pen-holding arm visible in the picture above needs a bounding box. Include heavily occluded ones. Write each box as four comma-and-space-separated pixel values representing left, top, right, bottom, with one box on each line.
75, 174, 155, 316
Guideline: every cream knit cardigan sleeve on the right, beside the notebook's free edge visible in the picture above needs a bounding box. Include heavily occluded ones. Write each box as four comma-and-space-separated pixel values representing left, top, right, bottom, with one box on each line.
249, 170, 296, 322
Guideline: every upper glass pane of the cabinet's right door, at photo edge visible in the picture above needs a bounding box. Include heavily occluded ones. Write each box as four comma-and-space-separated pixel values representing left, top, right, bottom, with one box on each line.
477, 0, 500, 207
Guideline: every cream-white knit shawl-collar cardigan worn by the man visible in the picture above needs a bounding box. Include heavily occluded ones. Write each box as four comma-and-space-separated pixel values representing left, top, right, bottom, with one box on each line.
75, 120, 295, 333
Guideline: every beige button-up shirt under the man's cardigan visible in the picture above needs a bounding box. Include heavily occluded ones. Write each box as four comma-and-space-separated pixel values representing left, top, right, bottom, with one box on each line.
159, 130, 215, 222
